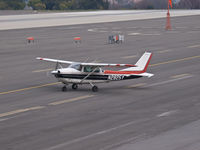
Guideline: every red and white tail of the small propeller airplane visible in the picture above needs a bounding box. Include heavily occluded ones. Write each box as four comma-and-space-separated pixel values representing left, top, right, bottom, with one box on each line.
120, 52, 153, 77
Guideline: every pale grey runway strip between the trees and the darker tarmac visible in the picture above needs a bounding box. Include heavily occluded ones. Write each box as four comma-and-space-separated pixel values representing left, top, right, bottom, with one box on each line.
0, 9, 200, 30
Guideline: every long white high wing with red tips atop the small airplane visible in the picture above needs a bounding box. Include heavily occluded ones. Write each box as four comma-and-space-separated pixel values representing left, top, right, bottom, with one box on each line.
36, 57, 136, 67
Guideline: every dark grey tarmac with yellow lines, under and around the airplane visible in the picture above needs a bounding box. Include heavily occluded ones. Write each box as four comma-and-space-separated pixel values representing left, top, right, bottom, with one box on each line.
0, 15, 200, 150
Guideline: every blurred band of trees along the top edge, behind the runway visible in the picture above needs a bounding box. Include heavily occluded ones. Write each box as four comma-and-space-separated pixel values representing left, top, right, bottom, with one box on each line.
0, 0, 200, 10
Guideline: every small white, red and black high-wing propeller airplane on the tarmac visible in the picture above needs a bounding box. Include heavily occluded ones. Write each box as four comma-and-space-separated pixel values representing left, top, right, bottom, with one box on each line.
36, 52, 153, 92
